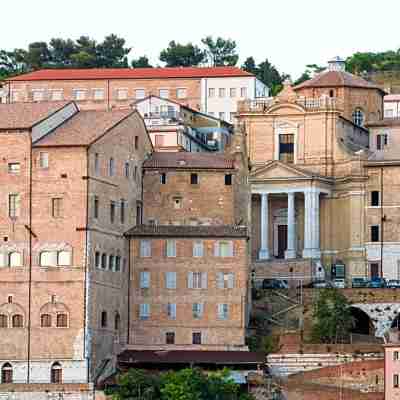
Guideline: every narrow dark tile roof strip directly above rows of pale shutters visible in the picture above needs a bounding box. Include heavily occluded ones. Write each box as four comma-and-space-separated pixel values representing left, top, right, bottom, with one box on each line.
125, 225, 248, 238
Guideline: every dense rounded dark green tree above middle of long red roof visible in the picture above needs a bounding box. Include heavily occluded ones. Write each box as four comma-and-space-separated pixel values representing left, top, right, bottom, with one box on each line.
160, 40, 205, 67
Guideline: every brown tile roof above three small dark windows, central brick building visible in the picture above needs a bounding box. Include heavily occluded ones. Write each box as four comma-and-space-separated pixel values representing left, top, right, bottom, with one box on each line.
143, 151, 234, 169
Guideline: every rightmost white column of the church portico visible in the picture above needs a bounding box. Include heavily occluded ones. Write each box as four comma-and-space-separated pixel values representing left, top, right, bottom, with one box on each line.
303, 188, 321, 258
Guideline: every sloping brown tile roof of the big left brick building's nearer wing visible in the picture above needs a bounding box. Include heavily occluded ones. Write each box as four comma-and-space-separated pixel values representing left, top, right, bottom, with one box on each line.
35, 109, 136, 147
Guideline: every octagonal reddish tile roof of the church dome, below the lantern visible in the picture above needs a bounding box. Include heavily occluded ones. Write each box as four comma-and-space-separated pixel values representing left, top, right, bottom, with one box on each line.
293, 71, 383, 91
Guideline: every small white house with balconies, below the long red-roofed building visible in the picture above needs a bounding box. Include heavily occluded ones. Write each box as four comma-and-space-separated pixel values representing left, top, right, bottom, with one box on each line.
135, 96, 233, 152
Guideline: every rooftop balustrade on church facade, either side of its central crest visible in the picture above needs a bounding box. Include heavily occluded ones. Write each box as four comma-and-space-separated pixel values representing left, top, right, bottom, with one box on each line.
238, 97, 343, 113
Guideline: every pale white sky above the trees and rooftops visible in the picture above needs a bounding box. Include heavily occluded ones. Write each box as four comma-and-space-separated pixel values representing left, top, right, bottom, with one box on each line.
0, 0, 400, 78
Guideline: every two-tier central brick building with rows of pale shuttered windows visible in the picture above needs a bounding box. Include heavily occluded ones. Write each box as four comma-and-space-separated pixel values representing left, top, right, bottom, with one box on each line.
126, 153, 250, 350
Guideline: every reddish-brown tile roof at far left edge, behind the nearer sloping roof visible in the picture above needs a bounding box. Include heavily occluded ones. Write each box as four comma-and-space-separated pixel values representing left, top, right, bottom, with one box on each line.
0, 101, 68, 130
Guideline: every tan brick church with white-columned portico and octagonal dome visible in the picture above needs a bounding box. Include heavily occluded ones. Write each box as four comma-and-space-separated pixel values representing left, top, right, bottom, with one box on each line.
238, 59, 399, 282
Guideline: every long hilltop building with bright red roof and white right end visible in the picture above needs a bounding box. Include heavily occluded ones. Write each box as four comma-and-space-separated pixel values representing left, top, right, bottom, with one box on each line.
5, 67, 268, 122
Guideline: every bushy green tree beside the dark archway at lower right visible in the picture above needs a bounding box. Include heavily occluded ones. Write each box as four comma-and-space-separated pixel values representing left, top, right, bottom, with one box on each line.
312, 289, 354, 343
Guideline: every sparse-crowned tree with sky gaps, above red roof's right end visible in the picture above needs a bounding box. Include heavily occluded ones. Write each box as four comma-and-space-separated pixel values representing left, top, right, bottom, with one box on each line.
201, 36, 239, 67
